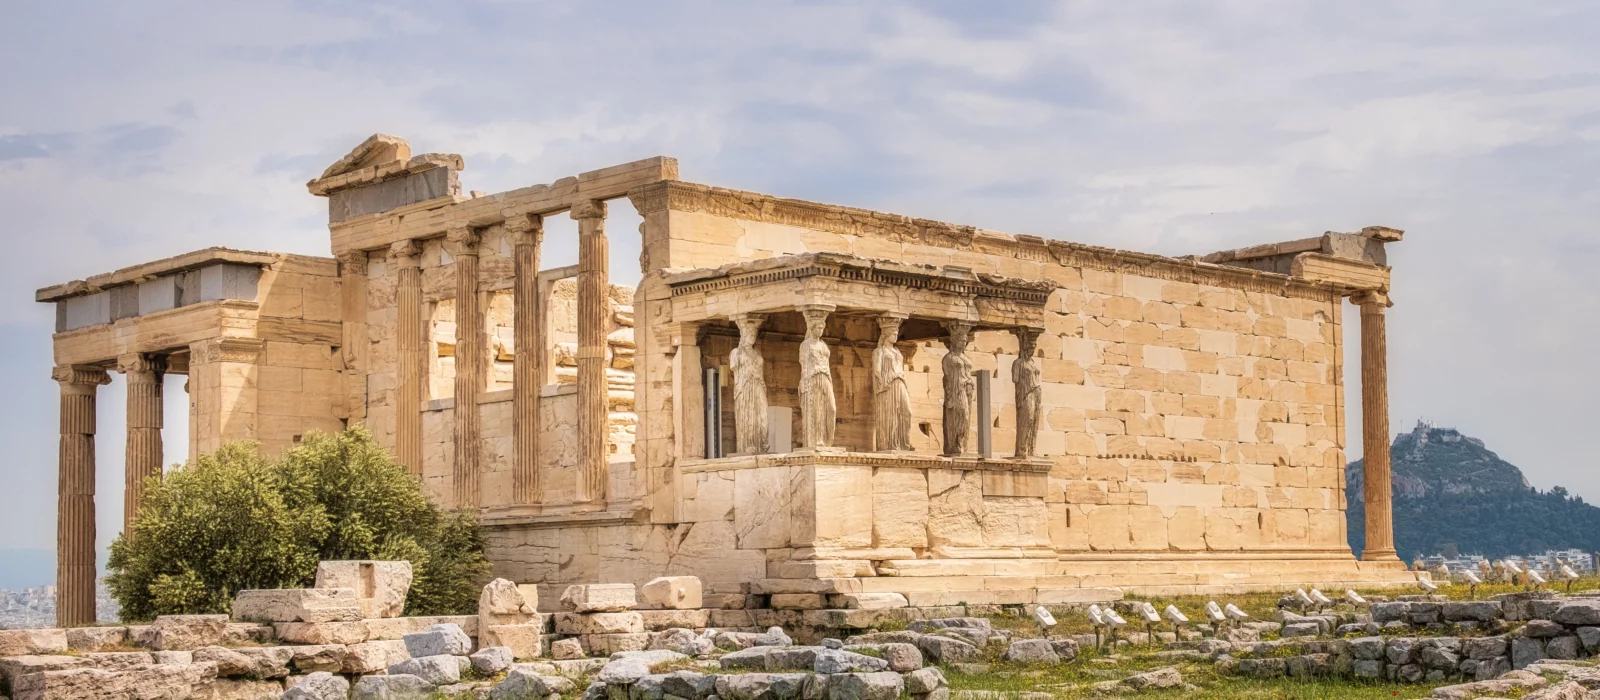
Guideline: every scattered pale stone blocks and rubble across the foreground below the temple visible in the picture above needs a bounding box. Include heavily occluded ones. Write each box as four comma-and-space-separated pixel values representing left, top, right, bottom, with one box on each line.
9, 563, 1600, 700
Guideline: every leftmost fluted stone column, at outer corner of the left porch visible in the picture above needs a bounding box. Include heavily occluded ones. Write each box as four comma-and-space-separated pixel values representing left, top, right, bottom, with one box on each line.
50, 364, 110, 626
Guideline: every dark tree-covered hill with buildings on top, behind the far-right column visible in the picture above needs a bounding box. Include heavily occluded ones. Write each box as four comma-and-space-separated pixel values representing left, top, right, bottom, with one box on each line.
1344, 422, 1600, 561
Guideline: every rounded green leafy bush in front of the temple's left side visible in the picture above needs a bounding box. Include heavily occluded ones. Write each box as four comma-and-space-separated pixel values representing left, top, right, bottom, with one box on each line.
107, 428, 490, 620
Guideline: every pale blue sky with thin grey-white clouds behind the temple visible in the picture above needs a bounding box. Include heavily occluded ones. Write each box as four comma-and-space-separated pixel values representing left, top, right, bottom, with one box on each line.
0, 0, 1600, 568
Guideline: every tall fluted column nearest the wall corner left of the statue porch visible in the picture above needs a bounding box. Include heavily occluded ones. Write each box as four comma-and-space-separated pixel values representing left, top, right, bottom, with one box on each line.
571, 201, 611, 503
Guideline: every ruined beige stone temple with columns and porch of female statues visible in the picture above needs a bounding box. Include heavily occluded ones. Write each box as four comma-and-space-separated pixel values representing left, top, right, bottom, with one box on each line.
37, 136, 1408, 623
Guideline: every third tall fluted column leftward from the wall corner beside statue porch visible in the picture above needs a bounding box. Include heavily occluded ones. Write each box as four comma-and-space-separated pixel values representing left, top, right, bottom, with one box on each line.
448, 227, 488, 507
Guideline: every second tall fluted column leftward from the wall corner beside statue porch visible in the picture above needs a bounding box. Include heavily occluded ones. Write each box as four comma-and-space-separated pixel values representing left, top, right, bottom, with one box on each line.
506, 216, 546, 503
